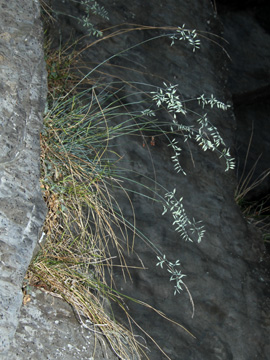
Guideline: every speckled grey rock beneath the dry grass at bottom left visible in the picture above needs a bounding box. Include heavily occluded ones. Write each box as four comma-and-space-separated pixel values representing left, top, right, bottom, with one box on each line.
7, 289, 118, 360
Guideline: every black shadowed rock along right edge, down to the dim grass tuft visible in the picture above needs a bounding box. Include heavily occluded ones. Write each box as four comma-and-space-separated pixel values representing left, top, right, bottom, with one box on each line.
219, 11, 270, 201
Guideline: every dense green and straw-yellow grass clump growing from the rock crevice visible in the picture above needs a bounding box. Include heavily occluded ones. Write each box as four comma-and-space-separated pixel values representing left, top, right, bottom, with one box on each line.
26, 39, 149, 359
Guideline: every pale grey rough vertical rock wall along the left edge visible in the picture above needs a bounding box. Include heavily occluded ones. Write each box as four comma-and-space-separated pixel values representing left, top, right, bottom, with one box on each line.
0, 0, 47, 354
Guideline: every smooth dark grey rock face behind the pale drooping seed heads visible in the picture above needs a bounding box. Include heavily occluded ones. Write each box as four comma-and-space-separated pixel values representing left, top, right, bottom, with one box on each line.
43, 0, 269, 360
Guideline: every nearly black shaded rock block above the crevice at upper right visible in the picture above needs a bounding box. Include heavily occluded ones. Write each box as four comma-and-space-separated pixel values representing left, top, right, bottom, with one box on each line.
222, 11, 270, 95
